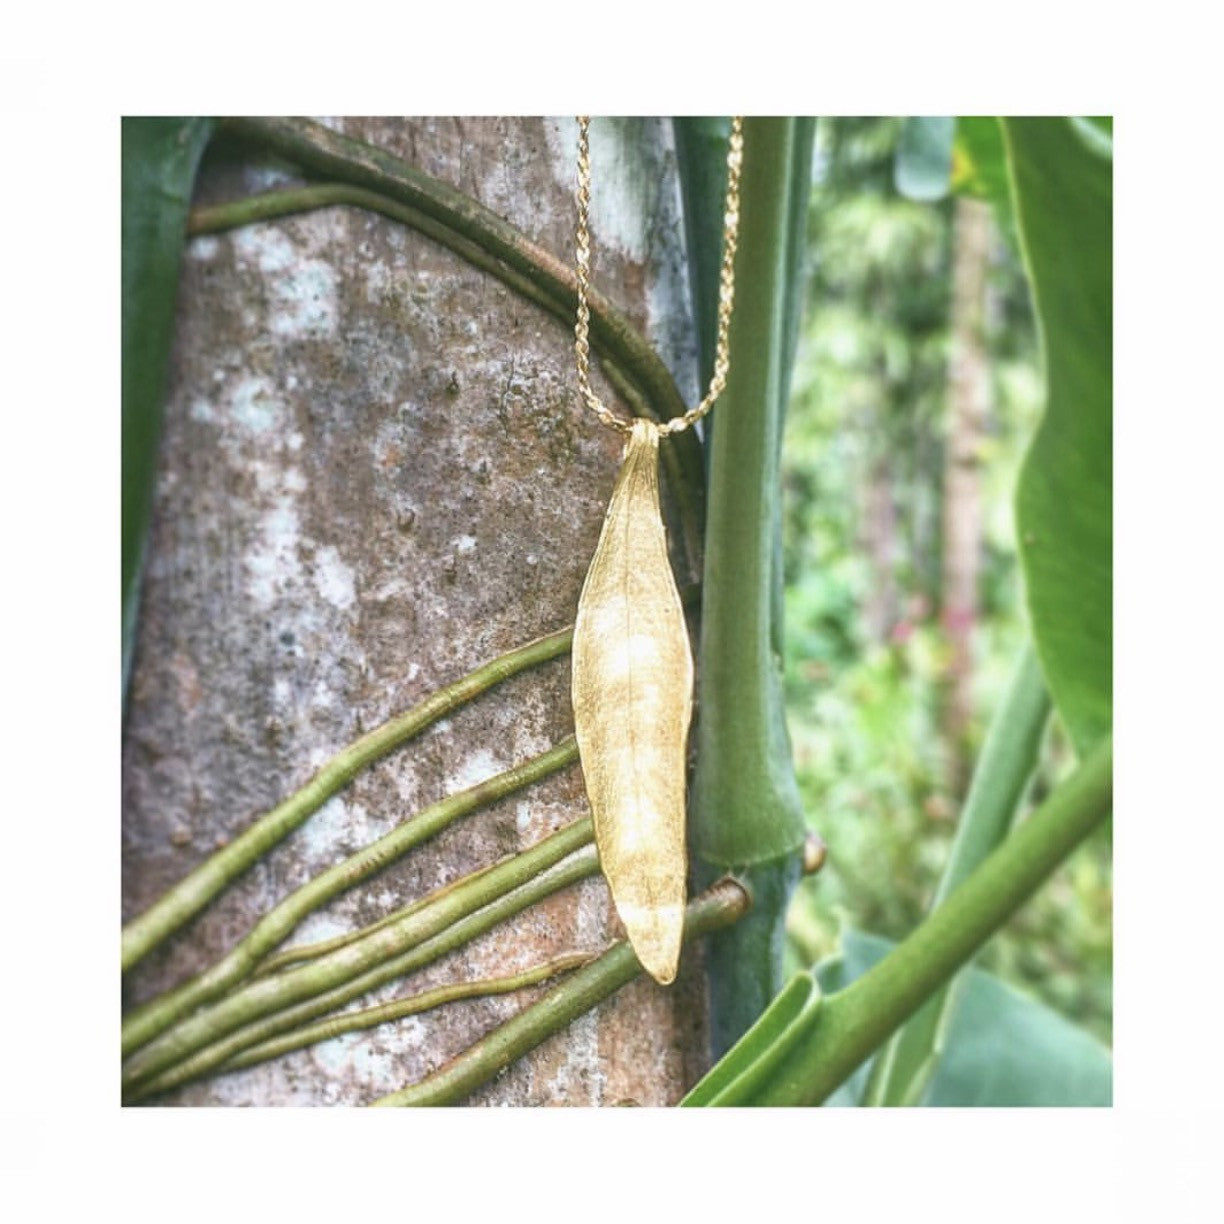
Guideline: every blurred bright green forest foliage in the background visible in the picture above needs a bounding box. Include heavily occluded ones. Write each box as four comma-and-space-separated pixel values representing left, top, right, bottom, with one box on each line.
783, 119, 1113, 1042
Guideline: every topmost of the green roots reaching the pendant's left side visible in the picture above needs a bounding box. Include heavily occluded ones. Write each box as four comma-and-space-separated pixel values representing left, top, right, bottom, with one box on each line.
122, 628, 574, 972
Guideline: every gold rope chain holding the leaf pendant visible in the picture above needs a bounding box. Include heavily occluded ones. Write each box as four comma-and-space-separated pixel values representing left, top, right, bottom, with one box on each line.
574, 115, 744, 433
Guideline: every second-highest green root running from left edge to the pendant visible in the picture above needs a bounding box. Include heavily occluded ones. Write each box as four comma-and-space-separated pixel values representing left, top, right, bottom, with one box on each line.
122, 736, 578, 1056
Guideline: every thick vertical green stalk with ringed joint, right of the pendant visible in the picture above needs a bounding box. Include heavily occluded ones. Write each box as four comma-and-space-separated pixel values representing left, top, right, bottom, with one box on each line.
690, 119, 805, 1053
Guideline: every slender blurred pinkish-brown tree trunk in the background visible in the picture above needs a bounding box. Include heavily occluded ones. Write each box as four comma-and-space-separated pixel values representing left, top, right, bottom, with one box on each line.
941, 190, 990, 794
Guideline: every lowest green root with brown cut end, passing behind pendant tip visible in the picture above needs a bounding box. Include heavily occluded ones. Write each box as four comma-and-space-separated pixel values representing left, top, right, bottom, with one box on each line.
373, 876, 752, 1105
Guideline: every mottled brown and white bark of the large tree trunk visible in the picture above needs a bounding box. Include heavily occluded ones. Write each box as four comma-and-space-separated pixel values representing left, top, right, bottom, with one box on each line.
124, 119, 706, 1105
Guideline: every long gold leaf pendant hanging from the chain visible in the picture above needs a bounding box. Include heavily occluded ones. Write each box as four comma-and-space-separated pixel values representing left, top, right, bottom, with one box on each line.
573, 419, 693, 985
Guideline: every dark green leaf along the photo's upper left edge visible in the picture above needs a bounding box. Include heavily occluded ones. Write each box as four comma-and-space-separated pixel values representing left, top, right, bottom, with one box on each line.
120, 119, 212, 692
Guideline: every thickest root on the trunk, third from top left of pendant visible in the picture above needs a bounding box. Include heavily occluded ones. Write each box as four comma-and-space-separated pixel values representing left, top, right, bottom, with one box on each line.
124, 820, 591, 1089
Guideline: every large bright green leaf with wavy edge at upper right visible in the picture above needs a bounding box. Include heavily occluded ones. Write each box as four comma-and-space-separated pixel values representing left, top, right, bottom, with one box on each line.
1002, 118, 1113, 755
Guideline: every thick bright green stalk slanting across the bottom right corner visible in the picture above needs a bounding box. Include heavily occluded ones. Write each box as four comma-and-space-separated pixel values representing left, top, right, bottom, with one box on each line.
685, 737, 1113, 1105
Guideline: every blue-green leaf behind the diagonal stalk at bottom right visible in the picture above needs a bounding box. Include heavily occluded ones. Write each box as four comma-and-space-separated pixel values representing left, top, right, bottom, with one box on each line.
816, 930, 1113, 1105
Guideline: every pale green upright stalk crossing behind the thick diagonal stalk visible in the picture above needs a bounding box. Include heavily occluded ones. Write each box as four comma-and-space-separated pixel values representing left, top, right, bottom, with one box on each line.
860, 644, 1050, 1105
